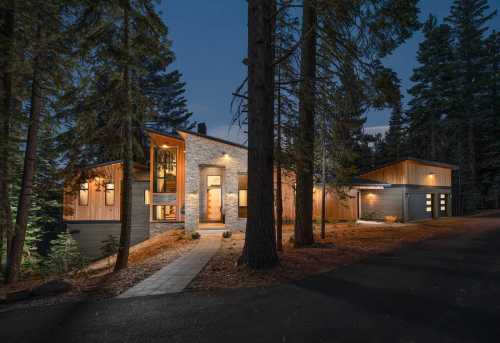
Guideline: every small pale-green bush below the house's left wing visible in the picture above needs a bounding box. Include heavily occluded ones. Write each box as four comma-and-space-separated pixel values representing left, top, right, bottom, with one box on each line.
46, 232, 86, 274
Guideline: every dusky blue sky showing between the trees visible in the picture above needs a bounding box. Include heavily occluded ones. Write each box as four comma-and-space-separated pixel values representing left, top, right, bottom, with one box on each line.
161, 0, 500, 141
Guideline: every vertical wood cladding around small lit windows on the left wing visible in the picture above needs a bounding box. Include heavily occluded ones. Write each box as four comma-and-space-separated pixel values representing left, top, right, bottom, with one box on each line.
63, 163, 123, 221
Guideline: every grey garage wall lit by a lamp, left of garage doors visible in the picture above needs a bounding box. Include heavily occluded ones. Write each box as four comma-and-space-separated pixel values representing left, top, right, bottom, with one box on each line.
360, 187, 404, 220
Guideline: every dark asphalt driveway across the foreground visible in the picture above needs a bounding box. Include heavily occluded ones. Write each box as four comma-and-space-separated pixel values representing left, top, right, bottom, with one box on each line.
0, 218, 500, 343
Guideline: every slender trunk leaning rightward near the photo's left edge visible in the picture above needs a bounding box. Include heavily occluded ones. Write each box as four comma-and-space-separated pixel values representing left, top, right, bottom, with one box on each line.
6, 23, 45, 283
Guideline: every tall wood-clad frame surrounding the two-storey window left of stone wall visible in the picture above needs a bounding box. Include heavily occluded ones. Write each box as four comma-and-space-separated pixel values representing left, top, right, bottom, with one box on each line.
149, 132, 186, 221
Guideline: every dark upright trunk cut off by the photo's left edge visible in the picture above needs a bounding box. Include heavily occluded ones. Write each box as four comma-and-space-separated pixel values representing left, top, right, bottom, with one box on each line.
0, 0, 15, 274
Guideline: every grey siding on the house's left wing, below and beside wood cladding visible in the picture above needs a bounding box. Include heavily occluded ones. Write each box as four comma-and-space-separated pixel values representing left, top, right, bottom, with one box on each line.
66, 181, 150, 258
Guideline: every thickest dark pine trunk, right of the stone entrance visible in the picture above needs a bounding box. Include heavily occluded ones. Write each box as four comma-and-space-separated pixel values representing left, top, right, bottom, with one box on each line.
239, 0, 278, 268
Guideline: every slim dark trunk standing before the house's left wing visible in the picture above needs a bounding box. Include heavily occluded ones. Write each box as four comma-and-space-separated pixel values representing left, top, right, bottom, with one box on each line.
115, 0, 133, 271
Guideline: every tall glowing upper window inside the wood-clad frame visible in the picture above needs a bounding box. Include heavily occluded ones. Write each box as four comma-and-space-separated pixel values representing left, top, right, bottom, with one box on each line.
154, 148, 177, 193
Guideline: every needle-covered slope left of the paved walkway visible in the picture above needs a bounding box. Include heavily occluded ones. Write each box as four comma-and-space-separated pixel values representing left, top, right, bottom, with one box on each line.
0, 229, 197, 307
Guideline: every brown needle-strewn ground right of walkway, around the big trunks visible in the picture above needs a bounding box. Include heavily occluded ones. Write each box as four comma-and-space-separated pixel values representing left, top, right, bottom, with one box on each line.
189, 218, 496, 290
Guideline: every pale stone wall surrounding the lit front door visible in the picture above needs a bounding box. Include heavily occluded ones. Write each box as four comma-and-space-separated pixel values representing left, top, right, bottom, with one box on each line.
185, 133, 247, 232
